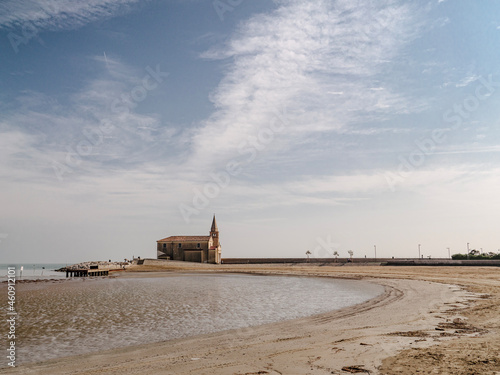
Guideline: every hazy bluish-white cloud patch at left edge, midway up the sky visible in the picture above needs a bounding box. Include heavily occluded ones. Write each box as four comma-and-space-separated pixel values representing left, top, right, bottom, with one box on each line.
0, 56, 180, 185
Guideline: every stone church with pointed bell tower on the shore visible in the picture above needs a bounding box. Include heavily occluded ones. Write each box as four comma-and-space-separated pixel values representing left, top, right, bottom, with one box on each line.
156, 215, 221, 264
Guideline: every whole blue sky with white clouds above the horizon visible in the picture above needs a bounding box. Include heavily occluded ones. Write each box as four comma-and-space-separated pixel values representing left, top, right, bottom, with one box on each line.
0, 0, 500, 263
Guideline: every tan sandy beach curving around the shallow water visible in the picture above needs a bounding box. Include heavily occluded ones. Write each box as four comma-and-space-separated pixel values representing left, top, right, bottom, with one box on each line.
0, 262, 500, 375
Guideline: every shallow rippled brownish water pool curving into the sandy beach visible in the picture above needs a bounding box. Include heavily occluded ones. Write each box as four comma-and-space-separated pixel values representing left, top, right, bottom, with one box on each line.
2, 274, 383, 363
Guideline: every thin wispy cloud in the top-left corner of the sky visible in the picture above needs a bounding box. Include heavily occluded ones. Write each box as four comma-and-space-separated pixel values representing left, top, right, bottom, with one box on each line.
0, 0, 142, 30
